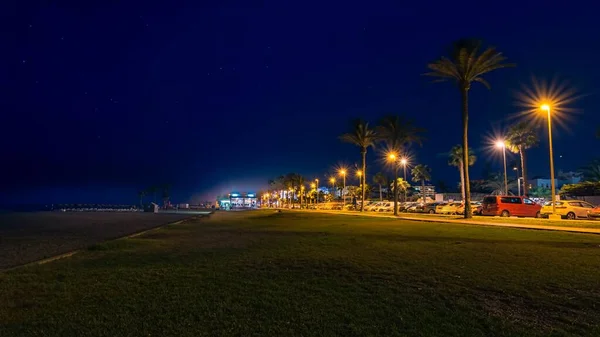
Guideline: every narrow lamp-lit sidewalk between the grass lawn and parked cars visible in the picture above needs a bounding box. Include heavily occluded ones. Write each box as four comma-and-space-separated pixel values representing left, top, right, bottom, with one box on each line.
288, 209, 600, 234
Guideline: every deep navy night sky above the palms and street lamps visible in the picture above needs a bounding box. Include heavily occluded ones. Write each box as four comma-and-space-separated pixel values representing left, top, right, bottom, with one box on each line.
0, 0, 600, 203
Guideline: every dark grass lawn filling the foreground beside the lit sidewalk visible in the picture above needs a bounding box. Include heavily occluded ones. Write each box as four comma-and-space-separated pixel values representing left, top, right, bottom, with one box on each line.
0, 211, 600, 337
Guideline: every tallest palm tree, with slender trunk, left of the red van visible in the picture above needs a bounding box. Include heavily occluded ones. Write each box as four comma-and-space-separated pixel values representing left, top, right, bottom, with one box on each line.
425, 39, 514, 218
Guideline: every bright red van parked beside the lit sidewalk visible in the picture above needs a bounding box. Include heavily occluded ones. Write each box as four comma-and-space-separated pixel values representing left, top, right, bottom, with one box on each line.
481, 195, 542, 218
